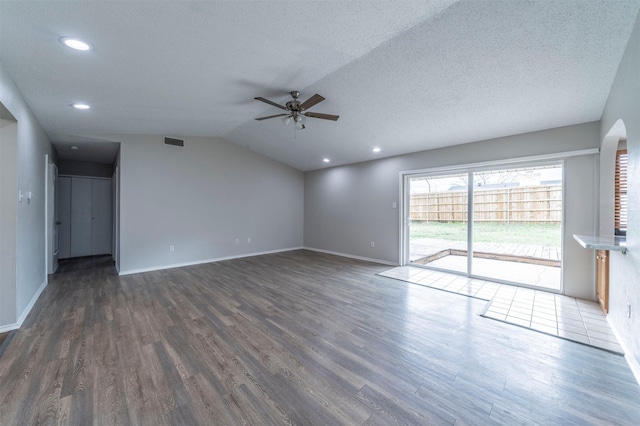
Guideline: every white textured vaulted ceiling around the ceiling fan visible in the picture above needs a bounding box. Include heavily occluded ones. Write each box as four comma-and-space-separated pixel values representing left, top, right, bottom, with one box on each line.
0, 0, 640, 170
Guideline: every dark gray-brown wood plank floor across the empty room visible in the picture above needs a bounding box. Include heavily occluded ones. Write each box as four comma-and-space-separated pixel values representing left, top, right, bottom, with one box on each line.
0, 251, 640, 425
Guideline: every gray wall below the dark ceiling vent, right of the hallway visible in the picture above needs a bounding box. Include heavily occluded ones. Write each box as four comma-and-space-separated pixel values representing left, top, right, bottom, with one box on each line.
111, 135, 304, 274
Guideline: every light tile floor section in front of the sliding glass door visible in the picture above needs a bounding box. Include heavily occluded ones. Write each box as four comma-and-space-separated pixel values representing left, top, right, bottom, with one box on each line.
379, 266, 623, 354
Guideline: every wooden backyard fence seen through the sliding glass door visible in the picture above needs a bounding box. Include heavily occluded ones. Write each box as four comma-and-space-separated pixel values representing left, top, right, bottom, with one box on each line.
410, 185, 562, 223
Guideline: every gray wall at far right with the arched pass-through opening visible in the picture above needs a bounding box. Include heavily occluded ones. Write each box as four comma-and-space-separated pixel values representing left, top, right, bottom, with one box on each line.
601, 10, 640, 372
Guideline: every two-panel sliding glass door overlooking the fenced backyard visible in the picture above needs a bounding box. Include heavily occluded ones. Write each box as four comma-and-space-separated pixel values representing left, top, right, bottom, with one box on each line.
405, 164, 563, 291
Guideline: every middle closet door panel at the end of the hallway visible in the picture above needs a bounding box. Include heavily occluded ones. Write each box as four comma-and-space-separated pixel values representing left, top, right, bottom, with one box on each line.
71, 177, 93, 257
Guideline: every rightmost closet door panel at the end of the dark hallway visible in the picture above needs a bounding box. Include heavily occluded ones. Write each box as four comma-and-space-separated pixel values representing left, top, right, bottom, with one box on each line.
91, 179, 113, 256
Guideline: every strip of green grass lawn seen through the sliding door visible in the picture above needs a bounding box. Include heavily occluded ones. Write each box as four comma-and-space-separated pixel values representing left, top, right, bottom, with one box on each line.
411, 221, 561, 247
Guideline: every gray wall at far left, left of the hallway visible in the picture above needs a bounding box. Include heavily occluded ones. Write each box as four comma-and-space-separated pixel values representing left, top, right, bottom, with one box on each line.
0, 64, 55, 327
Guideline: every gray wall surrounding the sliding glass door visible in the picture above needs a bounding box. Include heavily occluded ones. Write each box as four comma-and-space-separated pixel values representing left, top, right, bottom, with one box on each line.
304, 122, 600, 299
